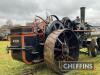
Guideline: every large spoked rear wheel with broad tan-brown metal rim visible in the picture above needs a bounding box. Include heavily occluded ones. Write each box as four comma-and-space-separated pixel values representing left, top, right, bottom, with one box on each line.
44, 29, 79, 73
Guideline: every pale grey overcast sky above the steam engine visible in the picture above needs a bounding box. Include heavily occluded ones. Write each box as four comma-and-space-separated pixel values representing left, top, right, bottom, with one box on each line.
0, 0, 100, 25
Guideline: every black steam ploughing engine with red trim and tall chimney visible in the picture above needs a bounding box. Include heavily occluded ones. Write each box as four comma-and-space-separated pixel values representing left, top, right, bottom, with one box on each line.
8, 7, 100, 72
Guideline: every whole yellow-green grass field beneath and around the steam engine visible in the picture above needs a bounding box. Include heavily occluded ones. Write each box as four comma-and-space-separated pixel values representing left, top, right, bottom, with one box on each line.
0, 41, 100, 75
